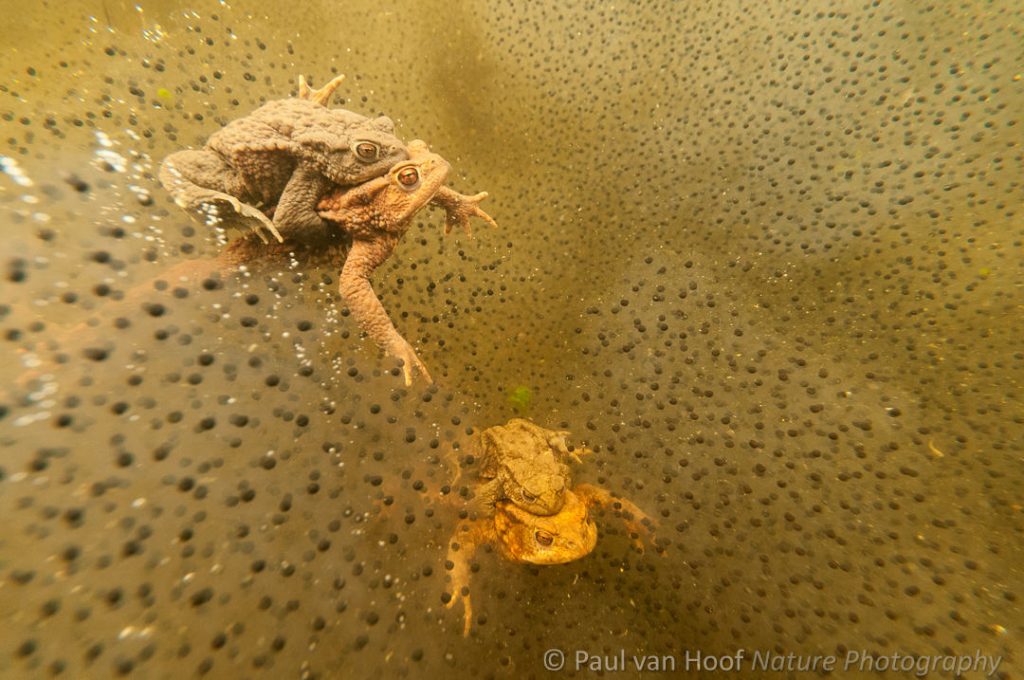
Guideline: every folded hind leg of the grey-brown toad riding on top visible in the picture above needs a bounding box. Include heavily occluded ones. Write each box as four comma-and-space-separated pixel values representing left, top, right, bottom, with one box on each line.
160, 150, 284, 243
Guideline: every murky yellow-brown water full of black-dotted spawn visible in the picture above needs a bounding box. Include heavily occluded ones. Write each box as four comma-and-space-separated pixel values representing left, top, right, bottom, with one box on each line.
0, 1, 1024, 678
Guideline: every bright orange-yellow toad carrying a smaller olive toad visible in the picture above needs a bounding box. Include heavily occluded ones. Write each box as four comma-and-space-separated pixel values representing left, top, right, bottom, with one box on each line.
445, 484, 651, 636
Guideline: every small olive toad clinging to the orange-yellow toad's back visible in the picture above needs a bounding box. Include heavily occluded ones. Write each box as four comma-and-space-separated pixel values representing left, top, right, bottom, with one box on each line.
474, 418, 590, 515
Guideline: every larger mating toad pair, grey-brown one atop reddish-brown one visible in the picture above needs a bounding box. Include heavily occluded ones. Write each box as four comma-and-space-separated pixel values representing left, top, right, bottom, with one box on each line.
160, 76, 496, 385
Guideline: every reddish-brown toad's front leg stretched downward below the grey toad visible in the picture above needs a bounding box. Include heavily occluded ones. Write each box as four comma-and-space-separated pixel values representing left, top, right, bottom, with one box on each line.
337, 233, 433, 385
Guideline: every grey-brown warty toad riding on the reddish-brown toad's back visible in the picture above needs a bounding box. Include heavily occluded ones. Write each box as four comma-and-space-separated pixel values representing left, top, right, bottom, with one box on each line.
160, 76, 409, 242
